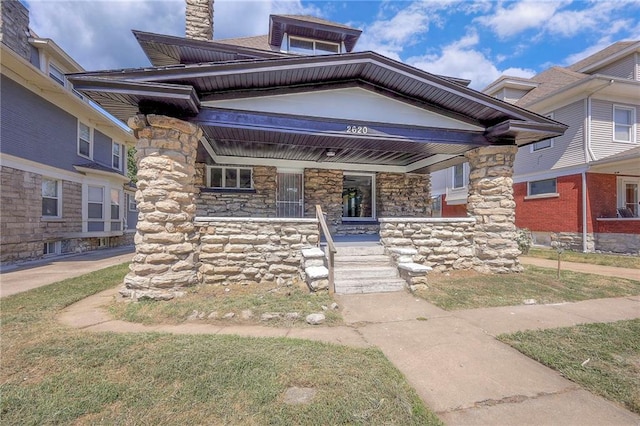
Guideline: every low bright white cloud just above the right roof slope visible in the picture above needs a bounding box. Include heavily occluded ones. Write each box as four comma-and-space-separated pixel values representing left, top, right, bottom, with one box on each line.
407, 32, 535, 90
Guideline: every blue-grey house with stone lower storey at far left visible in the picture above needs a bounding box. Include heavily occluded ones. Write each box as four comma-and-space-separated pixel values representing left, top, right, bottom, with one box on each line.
0, 1, 137, 263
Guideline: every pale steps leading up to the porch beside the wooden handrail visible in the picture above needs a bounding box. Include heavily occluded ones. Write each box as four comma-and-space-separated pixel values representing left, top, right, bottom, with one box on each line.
334, 244, 406, 294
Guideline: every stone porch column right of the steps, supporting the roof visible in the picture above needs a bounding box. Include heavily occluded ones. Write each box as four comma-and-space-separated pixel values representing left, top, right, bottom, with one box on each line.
465, 145, 522, 273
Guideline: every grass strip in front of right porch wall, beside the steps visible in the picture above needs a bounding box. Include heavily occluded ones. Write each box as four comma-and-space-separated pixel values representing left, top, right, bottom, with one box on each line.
417, 266, 640, 310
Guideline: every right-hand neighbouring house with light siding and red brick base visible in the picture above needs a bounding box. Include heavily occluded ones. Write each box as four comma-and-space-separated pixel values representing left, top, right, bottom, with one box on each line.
432, 41, 640, 253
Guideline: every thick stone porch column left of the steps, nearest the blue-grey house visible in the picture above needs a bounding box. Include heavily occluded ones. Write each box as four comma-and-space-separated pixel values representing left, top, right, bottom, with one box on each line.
120, 115, 202, 300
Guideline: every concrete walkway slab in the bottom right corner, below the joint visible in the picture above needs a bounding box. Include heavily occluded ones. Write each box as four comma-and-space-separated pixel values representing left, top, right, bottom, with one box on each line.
438, 390, 640, 426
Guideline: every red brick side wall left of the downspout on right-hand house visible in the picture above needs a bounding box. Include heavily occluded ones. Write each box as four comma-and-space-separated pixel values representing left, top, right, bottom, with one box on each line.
513, 174, 582, 232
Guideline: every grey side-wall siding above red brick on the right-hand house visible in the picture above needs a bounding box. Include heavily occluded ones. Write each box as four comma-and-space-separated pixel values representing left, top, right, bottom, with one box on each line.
514, 100, 585, 175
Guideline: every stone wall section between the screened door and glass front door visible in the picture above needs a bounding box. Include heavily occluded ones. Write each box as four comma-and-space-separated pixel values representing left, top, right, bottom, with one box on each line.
304, 169, 342, 225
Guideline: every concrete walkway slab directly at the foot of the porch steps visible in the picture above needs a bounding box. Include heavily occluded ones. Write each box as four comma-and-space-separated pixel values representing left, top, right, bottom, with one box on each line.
335, 291, 451, 324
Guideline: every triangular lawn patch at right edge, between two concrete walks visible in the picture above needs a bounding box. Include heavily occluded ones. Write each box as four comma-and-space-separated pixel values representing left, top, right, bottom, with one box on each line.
498, 319, 640, 414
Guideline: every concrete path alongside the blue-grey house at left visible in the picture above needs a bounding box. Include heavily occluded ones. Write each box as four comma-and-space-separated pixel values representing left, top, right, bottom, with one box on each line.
0, 246, 134, 297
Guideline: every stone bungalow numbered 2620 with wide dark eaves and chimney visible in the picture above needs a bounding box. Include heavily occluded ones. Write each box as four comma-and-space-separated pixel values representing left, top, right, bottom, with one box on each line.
68, 0, 566, 298
